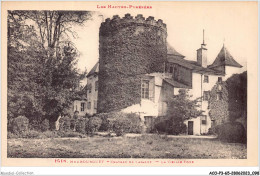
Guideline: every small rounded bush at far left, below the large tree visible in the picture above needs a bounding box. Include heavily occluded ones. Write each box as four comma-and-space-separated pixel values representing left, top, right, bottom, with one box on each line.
12, 116, 29, 134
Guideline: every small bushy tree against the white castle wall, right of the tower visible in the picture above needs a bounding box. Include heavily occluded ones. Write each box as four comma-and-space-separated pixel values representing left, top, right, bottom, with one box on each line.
166, 89, 202, 135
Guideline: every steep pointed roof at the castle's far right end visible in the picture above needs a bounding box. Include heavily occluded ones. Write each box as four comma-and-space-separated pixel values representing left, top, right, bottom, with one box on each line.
208, 45, 242, 68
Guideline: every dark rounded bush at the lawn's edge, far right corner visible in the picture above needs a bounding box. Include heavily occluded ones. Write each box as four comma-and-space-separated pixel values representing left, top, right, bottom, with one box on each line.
216, 122, 247, 143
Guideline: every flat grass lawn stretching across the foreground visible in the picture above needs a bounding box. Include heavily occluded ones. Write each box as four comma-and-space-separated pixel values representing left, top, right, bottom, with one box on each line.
7, 135, 247, 159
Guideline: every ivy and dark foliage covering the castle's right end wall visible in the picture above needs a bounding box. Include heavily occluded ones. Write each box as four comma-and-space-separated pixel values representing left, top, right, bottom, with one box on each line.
209, 72, 247, 125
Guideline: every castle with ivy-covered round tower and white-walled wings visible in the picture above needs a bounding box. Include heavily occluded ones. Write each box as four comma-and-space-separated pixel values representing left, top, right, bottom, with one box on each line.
87, 14, 242, 135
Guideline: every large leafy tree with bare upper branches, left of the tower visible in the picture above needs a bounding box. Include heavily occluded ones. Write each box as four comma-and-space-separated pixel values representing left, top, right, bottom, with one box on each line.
8, 11, 91, 129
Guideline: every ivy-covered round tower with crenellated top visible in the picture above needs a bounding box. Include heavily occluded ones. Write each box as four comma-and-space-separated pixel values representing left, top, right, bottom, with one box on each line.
98, 14, 167, 112
